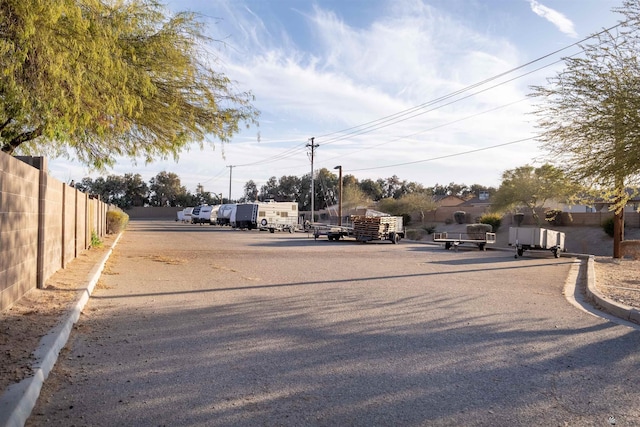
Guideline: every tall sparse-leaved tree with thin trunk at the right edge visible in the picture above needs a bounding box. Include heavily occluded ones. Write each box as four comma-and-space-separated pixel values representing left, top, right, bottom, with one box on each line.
532, 0, 640, 258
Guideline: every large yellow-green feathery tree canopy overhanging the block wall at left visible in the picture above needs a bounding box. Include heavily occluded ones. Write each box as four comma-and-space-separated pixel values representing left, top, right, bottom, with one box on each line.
0, 0, 258, 169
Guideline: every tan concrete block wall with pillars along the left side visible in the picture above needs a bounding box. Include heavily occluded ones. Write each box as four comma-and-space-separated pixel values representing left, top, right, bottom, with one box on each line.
0, 153, 109, 310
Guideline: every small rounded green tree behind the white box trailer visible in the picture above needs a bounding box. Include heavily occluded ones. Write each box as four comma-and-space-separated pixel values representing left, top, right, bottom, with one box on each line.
491, 164, 576, 223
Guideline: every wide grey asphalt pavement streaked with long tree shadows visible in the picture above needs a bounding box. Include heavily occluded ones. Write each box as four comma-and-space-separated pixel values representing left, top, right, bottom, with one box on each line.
27, 221, 640, 426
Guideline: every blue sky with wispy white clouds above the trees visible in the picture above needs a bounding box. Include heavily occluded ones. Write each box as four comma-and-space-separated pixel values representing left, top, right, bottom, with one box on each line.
50, 0, 621, 198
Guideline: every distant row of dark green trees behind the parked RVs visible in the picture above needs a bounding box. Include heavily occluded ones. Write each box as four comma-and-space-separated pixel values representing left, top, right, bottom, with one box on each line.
75, 168, 496, 213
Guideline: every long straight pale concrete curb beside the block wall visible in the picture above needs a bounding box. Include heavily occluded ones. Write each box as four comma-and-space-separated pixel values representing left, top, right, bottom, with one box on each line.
0, 233, 122, 427
